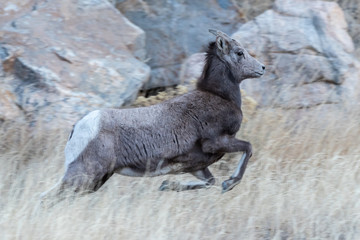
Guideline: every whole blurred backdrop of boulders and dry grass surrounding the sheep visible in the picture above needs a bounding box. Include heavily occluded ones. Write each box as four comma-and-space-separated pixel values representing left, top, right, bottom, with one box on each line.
0, 0, 360, 239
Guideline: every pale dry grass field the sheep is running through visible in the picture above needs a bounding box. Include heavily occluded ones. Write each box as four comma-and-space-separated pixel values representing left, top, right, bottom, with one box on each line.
0, 92, 360, 239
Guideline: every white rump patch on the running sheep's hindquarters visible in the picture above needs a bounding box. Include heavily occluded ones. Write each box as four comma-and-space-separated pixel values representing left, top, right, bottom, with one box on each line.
65, 110, 101, 170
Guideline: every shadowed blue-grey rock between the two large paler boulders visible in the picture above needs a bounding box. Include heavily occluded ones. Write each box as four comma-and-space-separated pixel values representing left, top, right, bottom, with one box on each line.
116, 0, 245, 89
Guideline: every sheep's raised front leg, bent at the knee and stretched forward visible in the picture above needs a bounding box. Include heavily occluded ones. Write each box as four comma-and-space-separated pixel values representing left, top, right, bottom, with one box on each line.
202, 135, 252, 193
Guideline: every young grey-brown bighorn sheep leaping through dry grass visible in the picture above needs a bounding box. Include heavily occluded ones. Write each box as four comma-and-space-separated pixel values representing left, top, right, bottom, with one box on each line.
43, 30, 265, 200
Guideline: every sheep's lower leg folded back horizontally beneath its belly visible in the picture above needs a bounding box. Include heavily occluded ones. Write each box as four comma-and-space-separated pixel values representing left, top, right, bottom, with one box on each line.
159, 168, 215, 192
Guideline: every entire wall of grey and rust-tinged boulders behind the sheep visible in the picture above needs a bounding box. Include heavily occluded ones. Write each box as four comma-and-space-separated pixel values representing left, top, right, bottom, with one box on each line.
0, 0, 360, 128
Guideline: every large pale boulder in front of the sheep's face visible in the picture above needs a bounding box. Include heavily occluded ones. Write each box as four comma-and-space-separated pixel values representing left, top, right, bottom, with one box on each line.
183, 0, 360, 108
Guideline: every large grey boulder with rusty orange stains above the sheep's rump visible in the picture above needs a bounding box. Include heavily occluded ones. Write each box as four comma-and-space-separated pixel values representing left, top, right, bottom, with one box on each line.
0, 0, 150, 125
